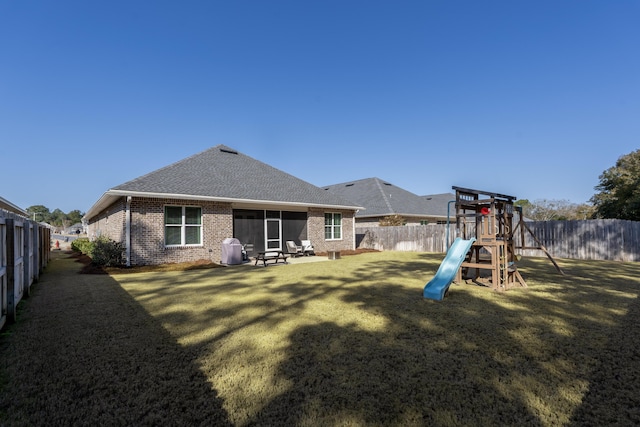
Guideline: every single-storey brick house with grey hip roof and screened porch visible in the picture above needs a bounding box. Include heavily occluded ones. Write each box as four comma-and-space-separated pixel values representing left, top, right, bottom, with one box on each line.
84, 145, 362, 265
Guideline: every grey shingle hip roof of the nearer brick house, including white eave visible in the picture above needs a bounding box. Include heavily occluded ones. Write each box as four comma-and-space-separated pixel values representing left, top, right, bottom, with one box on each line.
85, 145, 362, 219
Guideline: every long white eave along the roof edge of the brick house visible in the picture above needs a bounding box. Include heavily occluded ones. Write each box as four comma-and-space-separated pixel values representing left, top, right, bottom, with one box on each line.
83, 190, 364, 221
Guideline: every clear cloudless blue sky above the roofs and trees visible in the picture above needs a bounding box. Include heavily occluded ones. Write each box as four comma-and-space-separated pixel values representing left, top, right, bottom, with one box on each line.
0, 0, 640, 212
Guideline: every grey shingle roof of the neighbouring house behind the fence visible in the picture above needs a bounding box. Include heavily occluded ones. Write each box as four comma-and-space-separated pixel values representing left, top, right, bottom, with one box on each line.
322, 178, 448, 218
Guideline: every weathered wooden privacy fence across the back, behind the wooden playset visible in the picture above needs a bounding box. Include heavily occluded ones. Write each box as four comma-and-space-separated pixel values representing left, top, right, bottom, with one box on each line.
356, 219, 640, 261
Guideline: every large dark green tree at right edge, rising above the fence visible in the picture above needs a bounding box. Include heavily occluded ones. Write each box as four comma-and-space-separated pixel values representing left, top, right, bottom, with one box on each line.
590, 149, 640, 221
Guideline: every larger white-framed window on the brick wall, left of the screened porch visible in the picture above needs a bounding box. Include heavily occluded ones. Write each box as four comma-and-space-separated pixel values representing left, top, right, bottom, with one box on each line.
164, 206, 202, 246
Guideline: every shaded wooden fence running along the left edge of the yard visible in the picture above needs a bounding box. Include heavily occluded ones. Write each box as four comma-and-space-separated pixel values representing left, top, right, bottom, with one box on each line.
0, 209, 51, 328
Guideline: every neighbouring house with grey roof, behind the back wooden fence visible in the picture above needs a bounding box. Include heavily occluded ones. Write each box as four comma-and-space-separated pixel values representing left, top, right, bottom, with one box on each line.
322, 178, 455, 227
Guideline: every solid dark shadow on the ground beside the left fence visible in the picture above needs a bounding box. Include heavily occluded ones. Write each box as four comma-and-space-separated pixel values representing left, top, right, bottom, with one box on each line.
0, 254, 231, 425
